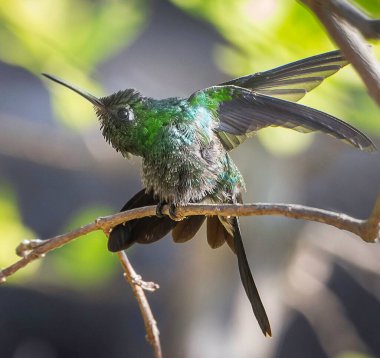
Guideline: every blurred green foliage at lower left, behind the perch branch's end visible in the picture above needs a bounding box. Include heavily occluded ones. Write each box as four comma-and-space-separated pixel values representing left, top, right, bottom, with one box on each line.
0, 184, 119, 290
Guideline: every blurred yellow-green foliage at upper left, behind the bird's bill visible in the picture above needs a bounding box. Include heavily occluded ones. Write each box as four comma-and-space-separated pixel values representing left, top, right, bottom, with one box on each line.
0, 0, 147, 128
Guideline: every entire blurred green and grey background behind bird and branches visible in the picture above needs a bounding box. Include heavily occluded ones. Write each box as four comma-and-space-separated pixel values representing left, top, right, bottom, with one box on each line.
0, 0, 380, 358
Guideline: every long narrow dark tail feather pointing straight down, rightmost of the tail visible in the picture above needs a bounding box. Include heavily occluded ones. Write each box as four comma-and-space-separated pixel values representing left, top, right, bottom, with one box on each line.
232, 217, 272, 336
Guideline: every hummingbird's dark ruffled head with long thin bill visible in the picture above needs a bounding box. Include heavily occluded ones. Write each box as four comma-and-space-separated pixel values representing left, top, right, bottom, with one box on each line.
43, 73, 144, 156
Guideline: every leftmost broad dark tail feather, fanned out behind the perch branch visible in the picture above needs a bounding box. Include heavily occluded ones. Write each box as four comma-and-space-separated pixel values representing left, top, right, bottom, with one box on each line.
108, 189, 177, 252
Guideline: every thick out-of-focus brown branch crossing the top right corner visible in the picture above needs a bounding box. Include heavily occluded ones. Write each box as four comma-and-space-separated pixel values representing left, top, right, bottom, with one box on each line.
301, 0, 380, 106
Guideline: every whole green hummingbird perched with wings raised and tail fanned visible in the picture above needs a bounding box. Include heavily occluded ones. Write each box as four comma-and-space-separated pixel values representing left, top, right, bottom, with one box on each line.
43, 51, 375, 336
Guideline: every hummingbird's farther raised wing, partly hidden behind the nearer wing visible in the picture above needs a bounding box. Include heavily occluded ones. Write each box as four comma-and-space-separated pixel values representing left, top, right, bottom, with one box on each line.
219, 51, 348, 102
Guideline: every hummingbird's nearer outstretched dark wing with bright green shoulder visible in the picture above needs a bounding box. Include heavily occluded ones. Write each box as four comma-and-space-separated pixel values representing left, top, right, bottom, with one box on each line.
189, 85, 375, 151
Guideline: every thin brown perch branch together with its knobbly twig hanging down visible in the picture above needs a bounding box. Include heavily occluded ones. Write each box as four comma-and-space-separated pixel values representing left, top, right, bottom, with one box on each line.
0, 199, 380, 358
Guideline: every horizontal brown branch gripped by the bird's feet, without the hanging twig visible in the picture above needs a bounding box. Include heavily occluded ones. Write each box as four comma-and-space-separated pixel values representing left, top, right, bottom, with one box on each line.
0, 199, 380, 282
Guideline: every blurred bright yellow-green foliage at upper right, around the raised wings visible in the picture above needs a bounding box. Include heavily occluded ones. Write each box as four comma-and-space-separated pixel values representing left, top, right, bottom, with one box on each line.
171, 0, 380, 155
